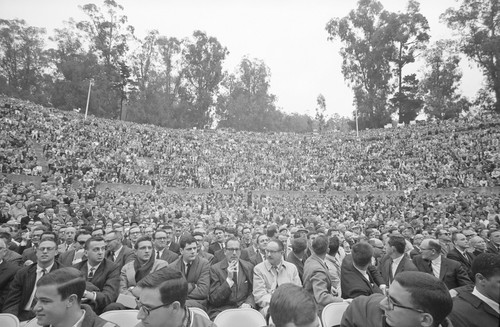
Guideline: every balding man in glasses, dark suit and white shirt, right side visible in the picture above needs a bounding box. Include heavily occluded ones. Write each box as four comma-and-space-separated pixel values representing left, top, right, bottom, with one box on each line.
413, 239, 472, 290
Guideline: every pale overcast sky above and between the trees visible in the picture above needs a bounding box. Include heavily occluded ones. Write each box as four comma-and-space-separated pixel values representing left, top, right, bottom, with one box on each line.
0, 0, 483, 116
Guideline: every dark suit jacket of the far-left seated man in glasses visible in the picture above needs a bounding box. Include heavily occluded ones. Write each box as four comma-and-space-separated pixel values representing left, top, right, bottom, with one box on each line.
3, 261, 62, 321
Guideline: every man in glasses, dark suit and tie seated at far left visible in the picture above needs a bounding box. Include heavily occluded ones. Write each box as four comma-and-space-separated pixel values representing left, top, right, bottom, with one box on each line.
3, 239, 62, 321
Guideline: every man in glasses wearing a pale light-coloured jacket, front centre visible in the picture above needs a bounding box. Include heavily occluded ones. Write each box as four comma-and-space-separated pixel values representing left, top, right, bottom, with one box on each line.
253, 239, 302, 317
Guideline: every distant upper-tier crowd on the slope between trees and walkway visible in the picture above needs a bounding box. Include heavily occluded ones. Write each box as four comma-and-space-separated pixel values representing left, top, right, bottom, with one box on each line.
0, 98, 500, 191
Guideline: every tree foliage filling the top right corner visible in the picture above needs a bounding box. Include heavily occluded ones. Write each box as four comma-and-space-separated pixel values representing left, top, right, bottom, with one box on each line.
441, 0, 500, 113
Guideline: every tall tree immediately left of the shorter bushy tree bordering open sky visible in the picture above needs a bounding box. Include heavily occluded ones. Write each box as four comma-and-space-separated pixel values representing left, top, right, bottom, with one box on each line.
180, 31, 228, 128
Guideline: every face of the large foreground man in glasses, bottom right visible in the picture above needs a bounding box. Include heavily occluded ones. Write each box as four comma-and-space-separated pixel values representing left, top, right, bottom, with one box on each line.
379, 281, 422, 327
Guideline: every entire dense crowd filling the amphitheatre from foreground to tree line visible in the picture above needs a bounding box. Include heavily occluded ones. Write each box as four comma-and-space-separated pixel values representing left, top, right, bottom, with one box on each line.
0, 99, 500, 327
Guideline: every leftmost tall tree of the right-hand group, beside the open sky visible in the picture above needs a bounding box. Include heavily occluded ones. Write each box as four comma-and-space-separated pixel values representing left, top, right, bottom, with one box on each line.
326, 0, 394, 129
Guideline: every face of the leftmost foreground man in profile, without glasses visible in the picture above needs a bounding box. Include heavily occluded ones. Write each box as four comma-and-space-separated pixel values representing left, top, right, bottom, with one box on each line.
33, 285, 68, 326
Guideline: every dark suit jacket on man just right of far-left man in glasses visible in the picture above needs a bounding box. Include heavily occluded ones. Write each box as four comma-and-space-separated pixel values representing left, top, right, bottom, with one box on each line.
73, 259, 120, 314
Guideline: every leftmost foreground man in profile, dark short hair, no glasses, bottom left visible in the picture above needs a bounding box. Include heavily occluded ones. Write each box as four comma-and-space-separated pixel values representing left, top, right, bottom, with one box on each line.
33, 267, 117, 327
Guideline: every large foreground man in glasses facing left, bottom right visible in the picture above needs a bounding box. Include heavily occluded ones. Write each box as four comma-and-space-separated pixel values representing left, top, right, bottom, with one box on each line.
340, 271, 453, 327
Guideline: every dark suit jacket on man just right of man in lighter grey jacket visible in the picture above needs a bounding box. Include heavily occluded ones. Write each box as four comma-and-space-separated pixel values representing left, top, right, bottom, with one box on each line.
340, 255, 384, 299
